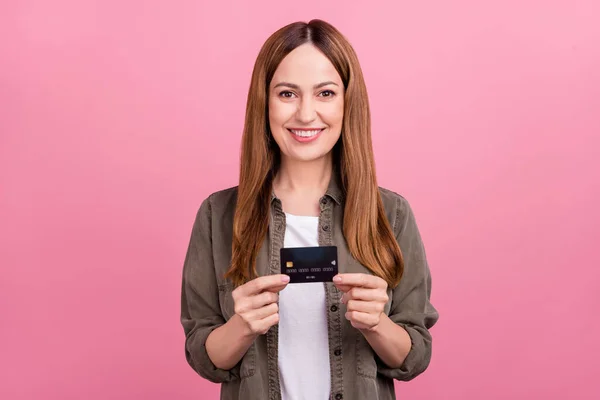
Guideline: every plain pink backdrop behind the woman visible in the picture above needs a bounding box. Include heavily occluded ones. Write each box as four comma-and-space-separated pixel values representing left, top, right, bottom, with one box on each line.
0, 0, 600, 400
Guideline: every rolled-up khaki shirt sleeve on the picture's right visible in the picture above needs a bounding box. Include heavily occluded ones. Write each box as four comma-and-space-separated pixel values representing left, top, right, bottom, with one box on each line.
378, 196, 439, 381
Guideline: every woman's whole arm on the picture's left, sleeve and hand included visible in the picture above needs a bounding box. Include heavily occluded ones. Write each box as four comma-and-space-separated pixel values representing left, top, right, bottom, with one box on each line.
181, 198, 289, 383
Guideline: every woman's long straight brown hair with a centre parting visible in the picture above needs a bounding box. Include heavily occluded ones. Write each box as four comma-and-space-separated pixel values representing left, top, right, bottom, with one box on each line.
226, 19, 404, 287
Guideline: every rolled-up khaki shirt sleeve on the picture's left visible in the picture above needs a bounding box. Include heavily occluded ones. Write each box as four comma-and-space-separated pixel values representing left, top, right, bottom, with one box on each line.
181, 198, 239, 383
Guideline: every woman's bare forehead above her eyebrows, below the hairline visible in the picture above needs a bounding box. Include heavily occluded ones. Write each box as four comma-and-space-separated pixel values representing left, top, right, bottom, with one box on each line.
271, 43, 342, 87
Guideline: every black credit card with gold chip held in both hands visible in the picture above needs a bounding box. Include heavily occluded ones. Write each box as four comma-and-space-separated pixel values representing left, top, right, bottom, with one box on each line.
281, 246, 338, 283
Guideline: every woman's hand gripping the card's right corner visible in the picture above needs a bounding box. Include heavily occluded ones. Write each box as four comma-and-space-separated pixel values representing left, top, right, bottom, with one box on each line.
333, 273, 389, 331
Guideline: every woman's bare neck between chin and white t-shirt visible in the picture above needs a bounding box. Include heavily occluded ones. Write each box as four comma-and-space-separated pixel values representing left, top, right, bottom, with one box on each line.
273, 153, 333, 196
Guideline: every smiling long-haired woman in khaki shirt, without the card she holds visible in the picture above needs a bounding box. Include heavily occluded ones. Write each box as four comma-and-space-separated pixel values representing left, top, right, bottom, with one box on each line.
181, 20, 438, 400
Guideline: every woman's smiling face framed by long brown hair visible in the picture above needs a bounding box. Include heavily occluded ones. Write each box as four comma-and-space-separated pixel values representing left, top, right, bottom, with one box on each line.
269, 44, 344, 161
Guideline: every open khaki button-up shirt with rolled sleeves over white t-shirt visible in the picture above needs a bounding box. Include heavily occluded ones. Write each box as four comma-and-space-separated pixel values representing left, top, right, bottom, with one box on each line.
181, 174, 438, 400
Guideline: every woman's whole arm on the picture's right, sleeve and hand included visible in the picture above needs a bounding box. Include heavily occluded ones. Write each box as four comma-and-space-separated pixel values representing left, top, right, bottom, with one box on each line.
333, 199, 438, 380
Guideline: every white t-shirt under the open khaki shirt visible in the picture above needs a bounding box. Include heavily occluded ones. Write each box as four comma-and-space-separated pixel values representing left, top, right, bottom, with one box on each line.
278, 213, 331, 400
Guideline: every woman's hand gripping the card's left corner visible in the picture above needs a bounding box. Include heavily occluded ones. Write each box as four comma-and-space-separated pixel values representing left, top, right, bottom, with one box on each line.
232, 274, 290, 336
